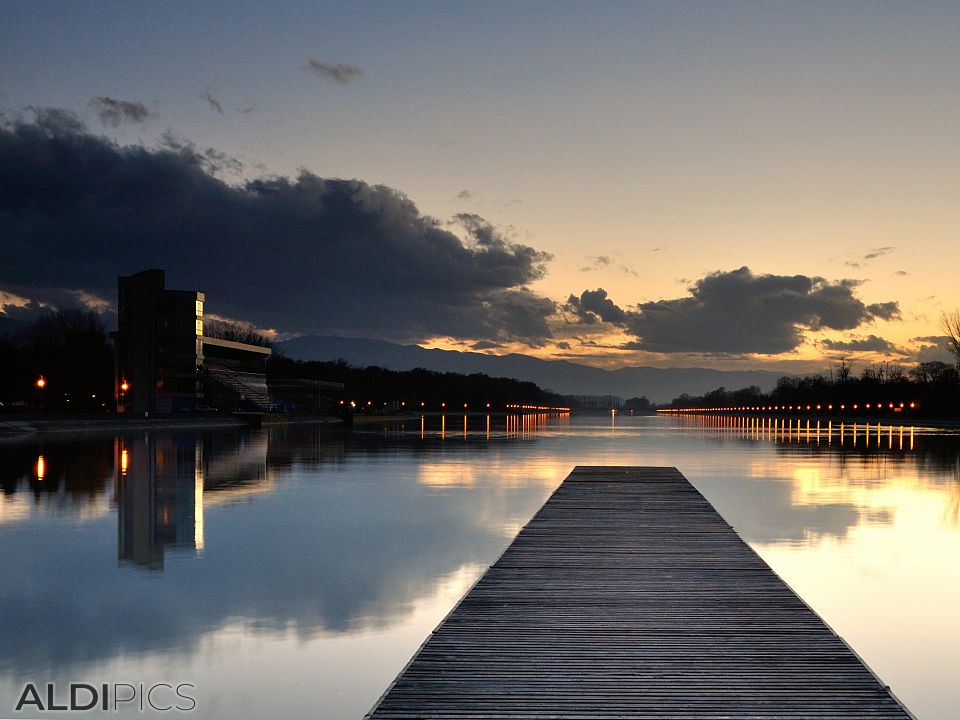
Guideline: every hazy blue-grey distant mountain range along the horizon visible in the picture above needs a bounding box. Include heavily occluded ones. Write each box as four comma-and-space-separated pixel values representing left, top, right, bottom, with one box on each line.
276, 335, 783, 403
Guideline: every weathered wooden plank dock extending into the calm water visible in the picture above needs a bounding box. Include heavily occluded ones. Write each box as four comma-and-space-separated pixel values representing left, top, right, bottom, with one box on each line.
367, 467, 913, 720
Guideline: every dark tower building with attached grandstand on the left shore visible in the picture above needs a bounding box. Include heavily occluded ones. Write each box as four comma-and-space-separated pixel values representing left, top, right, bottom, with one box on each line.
116, 270, 272, 413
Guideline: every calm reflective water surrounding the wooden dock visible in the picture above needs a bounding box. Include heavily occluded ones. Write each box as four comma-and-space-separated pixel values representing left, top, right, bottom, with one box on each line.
0, 416, 960, 720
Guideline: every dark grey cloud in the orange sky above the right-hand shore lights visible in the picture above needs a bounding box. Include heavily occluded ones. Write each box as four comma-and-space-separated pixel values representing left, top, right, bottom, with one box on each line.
567, 267, 899, 355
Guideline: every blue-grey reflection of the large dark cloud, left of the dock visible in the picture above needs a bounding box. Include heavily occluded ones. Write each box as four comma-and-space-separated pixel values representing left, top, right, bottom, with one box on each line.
0, 429, 561, 671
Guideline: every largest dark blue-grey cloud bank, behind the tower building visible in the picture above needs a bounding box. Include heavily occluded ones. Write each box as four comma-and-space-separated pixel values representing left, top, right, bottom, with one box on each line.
0, 112, 556, 345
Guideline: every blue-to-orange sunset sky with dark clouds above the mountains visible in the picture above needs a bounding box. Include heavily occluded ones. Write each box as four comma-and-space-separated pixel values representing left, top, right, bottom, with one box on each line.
0, 0, 960, 372
